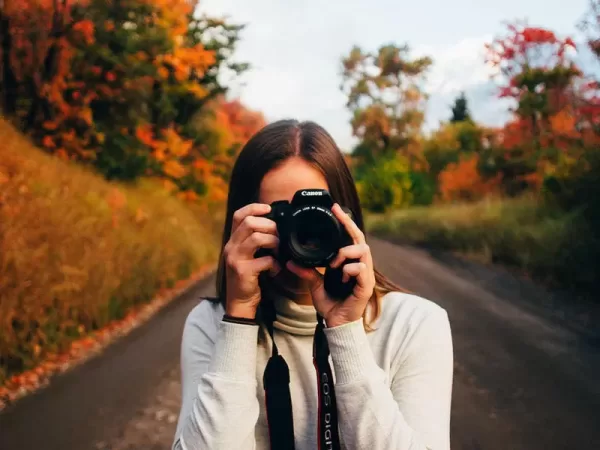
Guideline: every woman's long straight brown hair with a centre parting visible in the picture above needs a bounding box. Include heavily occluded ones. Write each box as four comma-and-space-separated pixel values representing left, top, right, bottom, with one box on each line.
216, 120, 404, 329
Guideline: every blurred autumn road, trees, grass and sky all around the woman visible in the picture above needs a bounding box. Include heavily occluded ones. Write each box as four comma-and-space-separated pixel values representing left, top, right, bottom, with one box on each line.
0, 0, 600, 450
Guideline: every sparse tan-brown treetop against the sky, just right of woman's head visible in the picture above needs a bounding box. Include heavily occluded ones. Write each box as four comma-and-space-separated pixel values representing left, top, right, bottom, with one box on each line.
341, 44, 431, 163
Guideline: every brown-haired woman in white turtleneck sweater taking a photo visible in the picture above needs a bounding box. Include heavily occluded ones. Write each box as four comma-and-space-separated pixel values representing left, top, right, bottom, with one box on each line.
173, 120, 453, 450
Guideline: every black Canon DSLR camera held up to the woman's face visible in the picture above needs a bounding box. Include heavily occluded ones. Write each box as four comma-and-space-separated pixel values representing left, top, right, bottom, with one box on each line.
260, 189, 356, 299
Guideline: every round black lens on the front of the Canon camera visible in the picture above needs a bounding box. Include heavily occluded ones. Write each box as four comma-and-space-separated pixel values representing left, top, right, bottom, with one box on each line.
290, 209, 339, 266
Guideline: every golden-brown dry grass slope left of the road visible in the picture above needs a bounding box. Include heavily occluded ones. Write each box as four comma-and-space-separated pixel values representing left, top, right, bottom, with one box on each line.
0, 120, 220, 384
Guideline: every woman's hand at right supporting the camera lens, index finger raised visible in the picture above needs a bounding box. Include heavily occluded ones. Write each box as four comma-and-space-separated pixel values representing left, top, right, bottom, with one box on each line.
287, 203, 375, 328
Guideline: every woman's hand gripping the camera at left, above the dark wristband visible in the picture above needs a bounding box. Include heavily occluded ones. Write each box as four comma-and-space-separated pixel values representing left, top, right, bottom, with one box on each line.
223, 203, 281, 319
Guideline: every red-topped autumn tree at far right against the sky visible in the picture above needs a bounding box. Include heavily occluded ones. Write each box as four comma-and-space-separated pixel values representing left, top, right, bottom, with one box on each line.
484, 23, 591, 195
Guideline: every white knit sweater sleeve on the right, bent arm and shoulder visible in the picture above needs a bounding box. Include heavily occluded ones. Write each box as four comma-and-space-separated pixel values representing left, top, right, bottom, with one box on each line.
326, 308, 453, 450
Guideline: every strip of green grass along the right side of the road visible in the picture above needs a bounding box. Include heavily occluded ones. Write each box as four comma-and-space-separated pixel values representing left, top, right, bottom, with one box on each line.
367, 198, 600, 291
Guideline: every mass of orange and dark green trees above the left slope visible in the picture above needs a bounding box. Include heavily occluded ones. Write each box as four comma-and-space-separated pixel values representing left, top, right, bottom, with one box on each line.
0, 0, 255, 199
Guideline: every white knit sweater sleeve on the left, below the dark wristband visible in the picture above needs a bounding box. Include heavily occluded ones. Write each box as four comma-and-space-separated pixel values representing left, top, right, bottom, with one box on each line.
172, 301, 259, 450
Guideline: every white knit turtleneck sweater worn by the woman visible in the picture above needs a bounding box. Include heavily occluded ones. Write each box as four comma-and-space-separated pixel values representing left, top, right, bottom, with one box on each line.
173, 292, 453, 450
